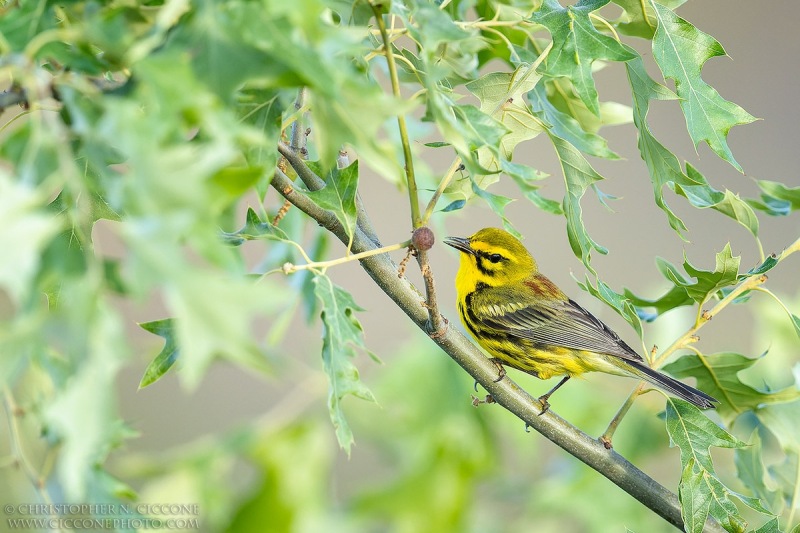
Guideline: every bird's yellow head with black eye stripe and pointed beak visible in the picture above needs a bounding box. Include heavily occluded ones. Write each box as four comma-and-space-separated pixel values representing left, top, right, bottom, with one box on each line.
444, 228, 538, 286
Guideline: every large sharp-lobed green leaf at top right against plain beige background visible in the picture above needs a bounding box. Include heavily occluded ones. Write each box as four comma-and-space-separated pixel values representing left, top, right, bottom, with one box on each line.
653, 2, 755, 172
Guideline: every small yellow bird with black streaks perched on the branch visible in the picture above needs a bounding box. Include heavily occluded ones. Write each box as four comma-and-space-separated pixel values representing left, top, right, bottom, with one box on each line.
444, 228, 718, 413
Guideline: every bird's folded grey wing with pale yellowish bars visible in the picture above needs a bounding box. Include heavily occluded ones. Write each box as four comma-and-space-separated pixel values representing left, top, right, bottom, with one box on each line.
479, 300, 642, 361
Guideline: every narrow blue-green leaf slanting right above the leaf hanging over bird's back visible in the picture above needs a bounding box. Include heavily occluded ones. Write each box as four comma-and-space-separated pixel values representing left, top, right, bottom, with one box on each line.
528, 83, 619, 159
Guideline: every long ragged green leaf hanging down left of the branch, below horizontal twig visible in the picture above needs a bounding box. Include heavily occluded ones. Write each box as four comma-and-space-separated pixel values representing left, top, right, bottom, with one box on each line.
313, 275, 375, 455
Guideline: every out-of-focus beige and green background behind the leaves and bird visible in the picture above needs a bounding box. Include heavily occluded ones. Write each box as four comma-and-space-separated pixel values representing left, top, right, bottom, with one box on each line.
0, 0, 800, 533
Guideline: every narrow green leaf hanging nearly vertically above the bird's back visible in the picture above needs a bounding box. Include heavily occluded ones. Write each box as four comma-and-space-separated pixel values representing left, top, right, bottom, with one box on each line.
550, 135, 608, 273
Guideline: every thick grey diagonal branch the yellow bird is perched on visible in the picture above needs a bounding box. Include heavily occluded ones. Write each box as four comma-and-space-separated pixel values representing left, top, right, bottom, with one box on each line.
272, 160, 724, 532
